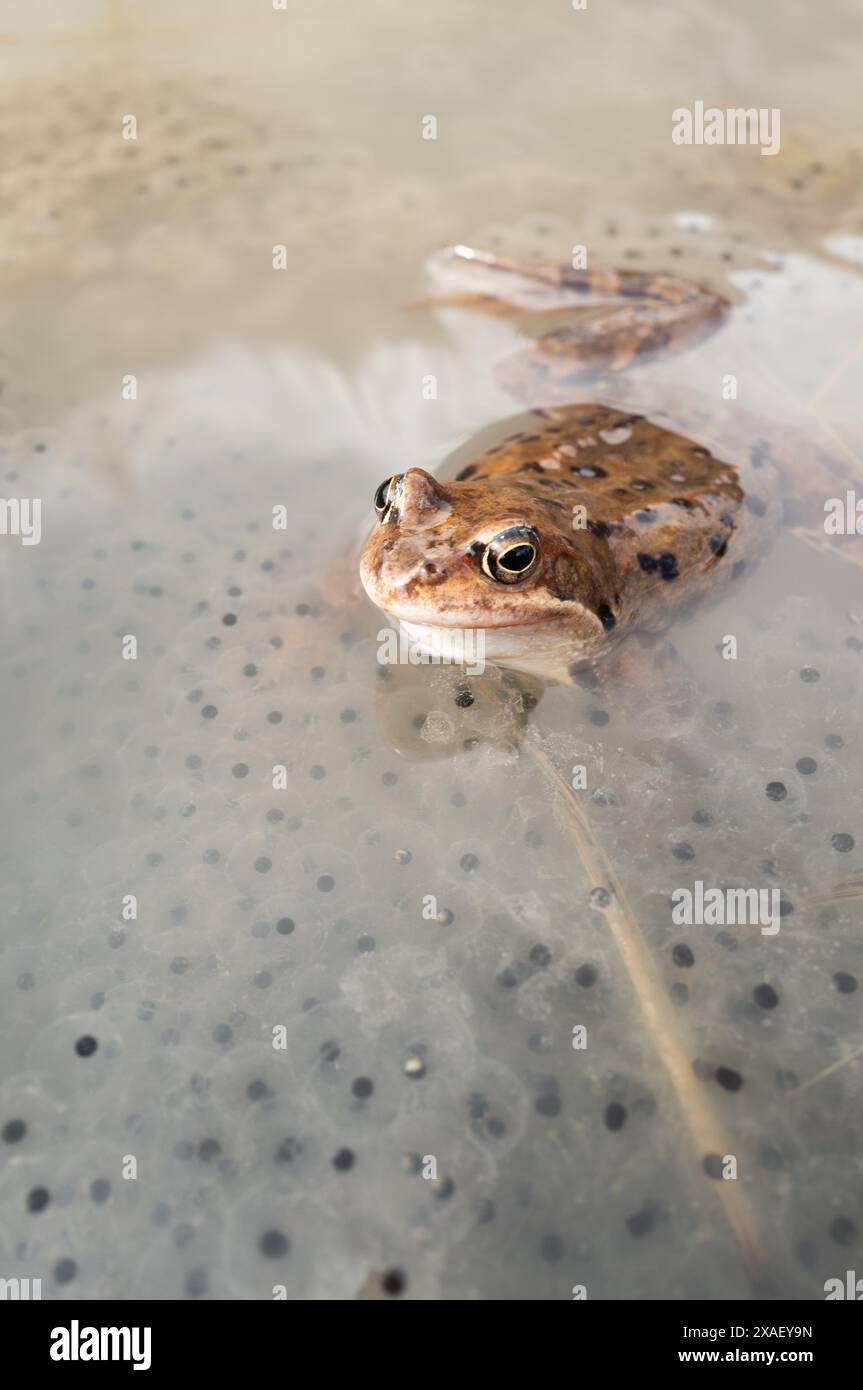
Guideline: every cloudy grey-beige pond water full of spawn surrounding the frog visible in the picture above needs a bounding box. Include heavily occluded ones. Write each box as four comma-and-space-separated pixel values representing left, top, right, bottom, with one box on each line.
0, 0, 863, 1298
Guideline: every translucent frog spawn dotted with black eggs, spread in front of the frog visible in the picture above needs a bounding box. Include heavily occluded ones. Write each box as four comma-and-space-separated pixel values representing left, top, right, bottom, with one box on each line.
0, 157, 862, 1298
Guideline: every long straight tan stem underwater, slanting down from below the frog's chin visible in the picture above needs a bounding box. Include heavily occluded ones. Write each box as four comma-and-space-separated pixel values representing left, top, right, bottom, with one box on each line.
524, 739, 764, 1279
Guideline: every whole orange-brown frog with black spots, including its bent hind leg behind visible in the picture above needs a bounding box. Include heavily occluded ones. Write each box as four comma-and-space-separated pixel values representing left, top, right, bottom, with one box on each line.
360, 246, 856, 689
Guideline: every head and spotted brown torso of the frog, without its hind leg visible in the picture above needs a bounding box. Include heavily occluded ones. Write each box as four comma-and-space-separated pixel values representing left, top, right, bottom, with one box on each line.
360, 403, 778, 670
